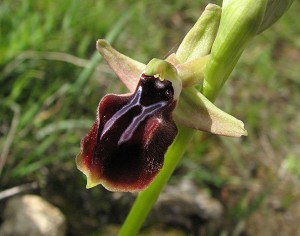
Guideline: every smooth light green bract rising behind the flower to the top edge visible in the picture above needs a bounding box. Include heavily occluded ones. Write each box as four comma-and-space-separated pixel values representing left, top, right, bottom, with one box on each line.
203, 0, 267, 100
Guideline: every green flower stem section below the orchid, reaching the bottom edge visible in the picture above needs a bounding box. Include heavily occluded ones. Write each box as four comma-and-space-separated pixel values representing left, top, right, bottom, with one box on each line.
119, 128, 194, 236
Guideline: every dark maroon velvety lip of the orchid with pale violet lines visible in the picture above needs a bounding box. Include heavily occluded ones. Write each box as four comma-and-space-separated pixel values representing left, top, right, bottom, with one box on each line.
77, 74, 177, 191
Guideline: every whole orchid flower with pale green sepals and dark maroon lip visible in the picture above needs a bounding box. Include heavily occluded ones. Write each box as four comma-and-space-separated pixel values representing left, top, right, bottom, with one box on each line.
76, 5, 247, 192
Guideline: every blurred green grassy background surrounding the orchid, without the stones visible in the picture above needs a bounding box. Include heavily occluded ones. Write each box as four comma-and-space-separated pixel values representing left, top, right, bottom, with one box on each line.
0, 0, 300, 235
